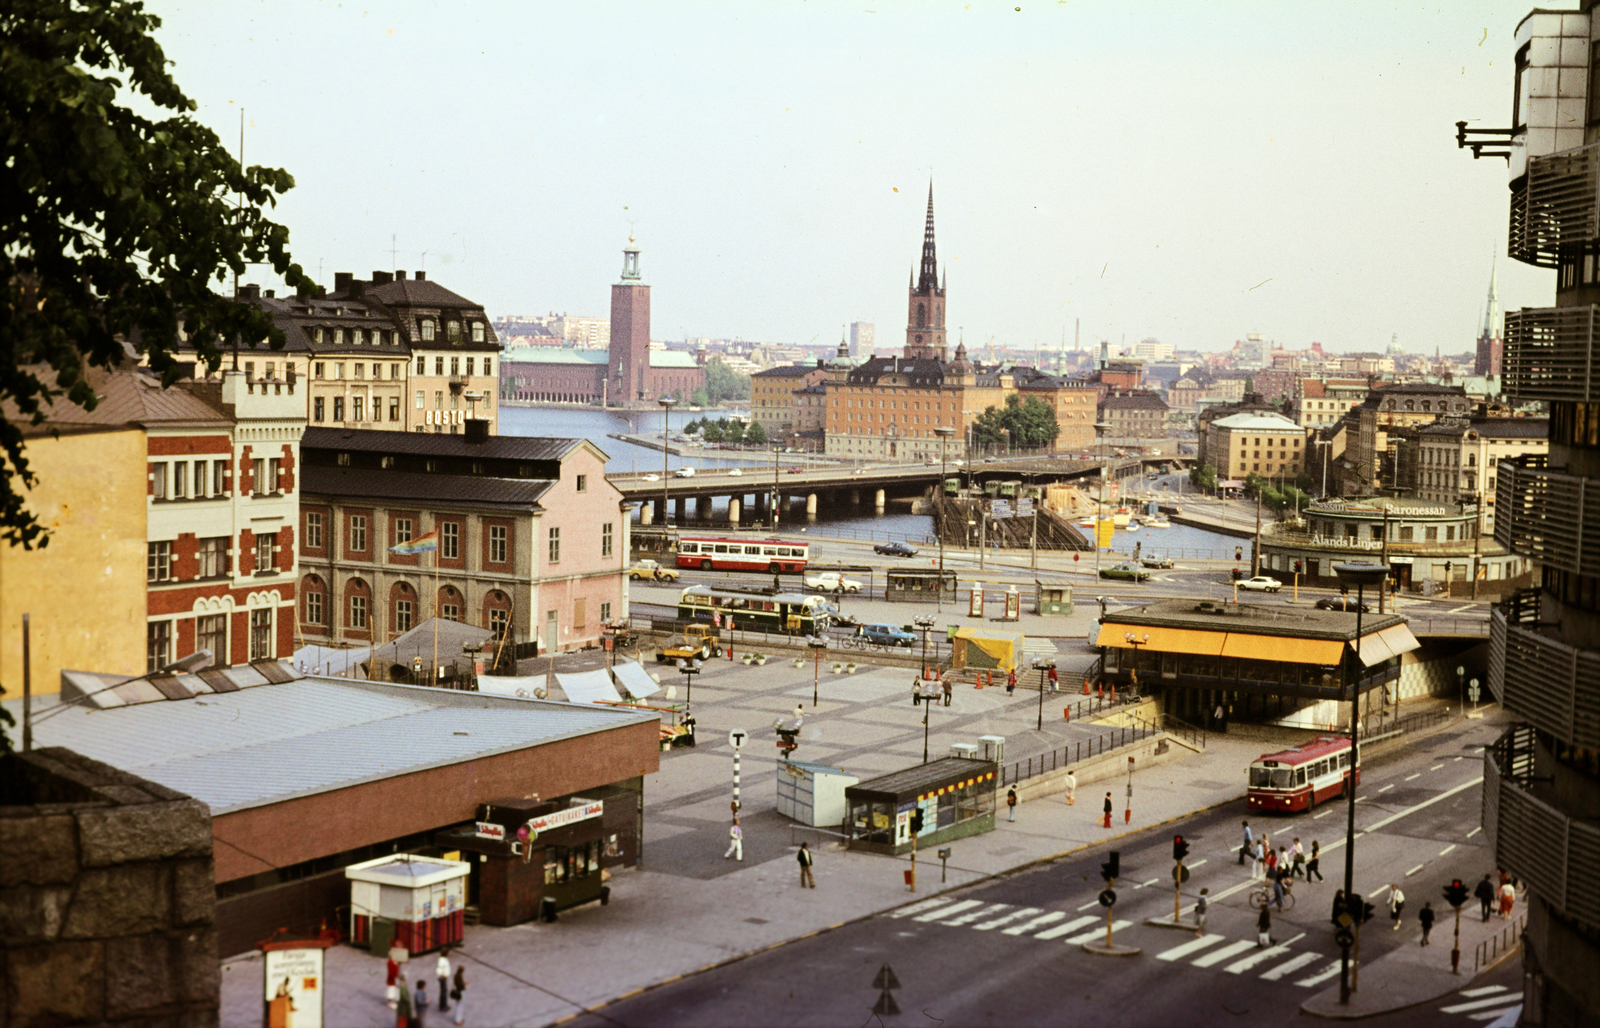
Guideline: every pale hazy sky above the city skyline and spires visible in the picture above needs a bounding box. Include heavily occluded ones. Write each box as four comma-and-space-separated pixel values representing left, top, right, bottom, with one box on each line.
149, 0, 1560, 352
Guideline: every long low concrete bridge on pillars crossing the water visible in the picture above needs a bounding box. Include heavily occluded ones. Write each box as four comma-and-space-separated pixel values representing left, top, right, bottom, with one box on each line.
606, 456, 1187, 525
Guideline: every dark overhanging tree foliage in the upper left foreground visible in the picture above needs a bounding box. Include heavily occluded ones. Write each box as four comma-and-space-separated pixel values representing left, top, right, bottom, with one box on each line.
0, 0, 314, 548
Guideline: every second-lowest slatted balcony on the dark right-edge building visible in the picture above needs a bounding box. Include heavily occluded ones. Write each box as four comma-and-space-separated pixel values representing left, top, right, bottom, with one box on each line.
1488, 591, 1600, 742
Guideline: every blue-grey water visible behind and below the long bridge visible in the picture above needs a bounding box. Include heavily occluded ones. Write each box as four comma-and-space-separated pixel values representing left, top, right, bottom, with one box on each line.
499, 405, 1248, 559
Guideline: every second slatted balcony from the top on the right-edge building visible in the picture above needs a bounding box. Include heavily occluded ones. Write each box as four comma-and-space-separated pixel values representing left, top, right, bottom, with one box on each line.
1501, 304, 1600, 402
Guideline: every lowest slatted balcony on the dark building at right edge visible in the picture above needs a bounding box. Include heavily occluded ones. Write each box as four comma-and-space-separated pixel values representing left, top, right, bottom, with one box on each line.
1483, 725, 1600, 926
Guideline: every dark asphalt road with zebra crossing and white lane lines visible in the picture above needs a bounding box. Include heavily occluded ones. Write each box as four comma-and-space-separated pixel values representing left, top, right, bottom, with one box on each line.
573, 710, 1498, 1028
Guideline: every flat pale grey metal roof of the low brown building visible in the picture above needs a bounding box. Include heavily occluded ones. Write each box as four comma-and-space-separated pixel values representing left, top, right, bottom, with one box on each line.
34, 679, 659, 815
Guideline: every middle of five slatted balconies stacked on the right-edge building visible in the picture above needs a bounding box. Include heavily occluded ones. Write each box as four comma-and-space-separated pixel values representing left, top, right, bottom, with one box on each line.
1494, 453, 1600, 575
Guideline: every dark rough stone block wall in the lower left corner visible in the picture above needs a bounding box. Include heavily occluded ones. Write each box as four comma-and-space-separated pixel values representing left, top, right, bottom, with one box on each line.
0, 748, 221, 1028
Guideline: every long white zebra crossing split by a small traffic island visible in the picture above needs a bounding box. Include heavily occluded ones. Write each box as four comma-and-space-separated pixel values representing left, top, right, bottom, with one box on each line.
886, 897, 1344, 979
